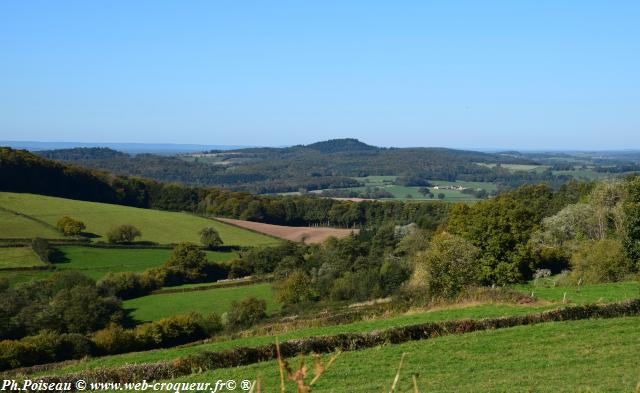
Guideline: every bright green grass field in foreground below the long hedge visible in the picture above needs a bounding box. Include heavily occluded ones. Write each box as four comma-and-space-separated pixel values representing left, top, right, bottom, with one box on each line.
173, 317, 640, 393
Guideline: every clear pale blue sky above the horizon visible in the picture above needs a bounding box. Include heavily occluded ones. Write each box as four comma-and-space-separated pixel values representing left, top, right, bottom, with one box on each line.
0, 0, 640, 150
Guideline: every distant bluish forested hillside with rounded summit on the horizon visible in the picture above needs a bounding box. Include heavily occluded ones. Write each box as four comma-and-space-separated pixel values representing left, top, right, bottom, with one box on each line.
27, 138, 542, 193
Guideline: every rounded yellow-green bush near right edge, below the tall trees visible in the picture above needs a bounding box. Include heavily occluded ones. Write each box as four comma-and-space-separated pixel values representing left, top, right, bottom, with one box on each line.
571, 239, 635, 283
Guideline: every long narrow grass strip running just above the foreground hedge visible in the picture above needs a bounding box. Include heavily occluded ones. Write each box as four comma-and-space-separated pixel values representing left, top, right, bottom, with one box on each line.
36, 304, 556, 373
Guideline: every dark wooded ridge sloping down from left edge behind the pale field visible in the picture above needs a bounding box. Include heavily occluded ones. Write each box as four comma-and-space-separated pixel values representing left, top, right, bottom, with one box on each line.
0, 148, 448, 228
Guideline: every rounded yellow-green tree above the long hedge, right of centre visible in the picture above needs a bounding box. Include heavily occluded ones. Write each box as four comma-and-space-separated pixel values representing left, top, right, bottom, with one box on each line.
412, 232, 481, 298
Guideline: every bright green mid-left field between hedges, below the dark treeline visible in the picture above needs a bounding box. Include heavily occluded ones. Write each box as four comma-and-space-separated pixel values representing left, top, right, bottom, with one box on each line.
123, 283, 279, 321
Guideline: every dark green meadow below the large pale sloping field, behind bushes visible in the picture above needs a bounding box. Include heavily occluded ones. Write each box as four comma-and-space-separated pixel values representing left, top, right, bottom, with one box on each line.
55, 246, 238, 280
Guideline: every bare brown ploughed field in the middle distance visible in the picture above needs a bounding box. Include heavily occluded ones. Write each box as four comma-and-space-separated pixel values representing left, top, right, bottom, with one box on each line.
216, 218, 358, 244
